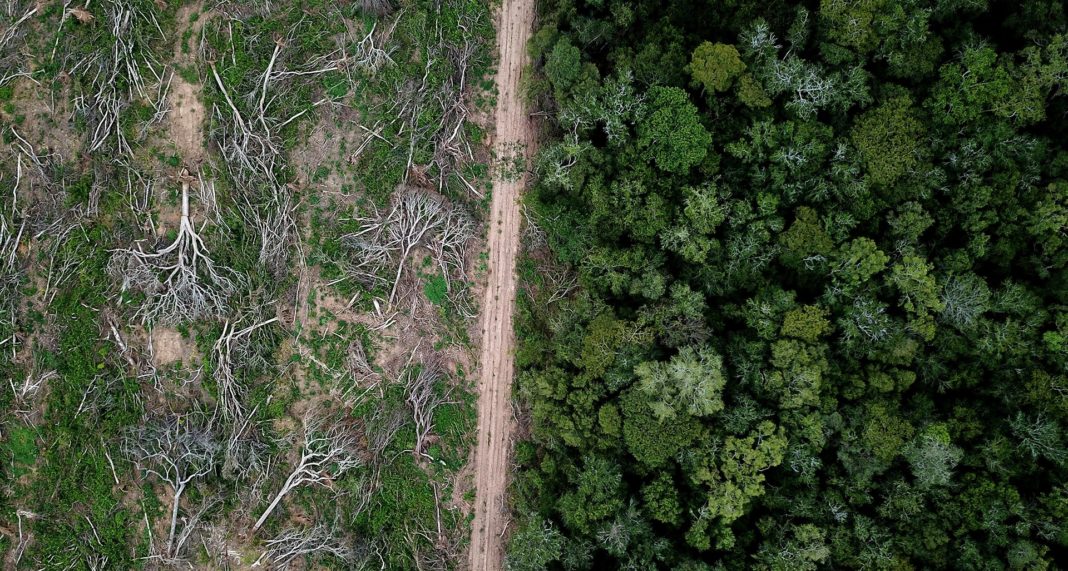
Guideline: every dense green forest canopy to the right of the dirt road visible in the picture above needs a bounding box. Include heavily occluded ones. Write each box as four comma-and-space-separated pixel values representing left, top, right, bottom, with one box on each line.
507, 0, 1068, 570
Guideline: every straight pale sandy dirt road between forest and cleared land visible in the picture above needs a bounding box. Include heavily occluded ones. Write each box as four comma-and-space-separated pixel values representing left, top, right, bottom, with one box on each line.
470, 0, 534, 571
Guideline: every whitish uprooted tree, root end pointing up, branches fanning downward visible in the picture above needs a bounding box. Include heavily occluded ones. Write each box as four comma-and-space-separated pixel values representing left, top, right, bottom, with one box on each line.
108, 176, 239, 324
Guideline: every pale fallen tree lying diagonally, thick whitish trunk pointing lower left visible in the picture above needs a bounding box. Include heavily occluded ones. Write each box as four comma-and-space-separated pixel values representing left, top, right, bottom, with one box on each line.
252, 412, 361, 530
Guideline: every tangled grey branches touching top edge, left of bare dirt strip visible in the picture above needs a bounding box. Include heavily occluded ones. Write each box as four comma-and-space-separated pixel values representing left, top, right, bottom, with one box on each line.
61, 0, 173, 156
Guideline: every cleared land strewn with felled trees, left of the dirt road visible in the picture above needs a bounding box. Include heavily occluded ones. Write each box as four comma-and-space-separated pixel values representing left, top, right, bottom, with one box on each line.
0, 0, 496, 570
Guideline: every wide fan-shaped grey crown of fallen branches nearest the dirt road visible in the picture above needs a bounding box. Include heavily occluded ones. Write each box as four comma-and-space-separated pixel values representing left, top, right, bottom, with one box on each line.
341, 189, 477, 304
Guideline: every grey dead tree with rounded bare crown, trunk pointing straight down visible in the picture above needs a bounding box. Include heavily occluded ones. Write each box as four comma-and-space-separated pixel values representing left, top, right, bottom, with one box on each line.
124, 412, 219, 560
